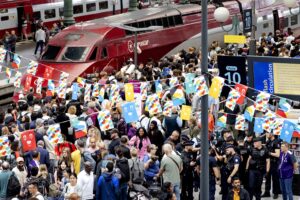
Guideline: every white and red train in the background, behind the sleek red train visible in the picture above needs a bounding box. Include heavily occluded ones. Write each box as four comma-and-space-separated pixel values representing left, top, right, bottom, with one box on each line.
0, 0, 141, 38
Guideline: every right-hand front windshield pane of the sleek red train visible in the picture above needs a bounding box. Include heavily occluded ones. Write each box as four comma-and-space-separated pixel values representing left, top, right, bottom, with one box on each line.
61, 47, 88, 62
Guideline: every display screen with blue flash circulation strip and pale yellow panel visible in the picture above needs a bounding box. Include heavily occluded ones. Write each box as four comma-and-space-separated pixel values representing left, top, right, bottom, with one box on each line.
247, 56, 300, 101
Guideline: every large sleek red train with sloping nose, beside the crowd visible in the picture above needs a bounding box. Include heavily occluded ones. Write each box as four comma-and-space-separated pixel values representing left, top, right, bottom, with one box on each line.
21, 1, 298, 86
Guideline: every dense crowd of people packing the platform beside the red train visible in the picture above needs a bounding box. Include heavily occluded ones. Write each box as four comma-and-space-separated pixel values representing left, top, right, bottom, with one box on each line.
0, 25, 299, 200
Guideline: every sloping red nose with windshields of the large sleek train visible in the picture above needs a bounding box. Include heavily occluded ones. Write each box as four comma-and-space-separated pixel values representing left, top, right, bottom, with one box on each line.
37, 29, 101, 81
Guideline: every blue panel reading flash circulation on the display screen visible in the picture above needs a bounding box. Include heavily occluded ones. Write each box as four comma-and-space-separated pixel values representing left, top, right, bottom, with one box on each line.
253, 62, 274, 94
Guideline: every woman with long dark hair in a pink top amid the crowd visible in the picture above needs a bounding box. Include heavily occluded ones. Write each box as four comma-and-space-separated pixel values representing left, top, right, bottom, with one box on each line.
128, 127, 151, 159
